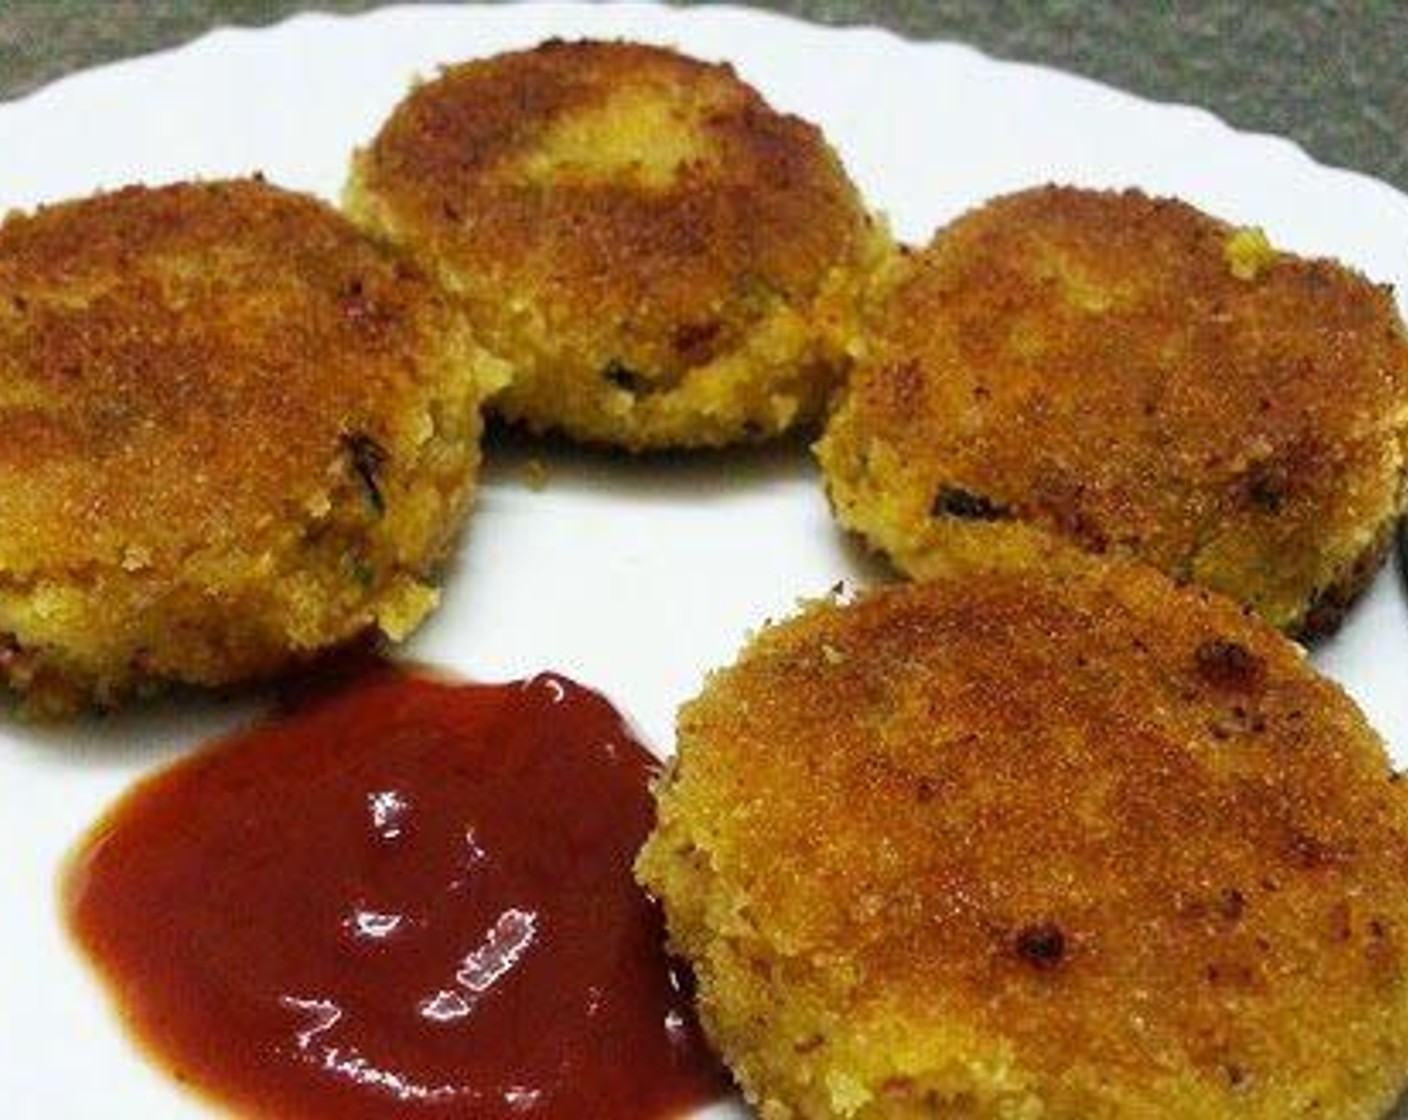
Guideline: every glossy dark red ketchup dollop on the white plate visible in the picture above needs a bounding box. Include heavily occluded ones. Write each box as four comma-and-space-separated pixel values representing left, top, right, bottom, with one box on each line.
66, 669, 725, 1119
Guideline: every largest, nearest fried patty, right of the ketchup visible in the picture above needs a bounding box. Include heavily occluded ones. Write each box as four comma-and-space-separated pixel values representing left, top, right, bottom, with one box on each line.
638, 558, 1408, 1120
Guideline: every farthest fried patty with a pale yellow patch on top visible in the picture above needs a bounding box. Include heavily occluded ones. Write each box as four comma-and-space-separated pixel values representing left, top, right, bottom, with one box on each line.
345, 41, 890, 449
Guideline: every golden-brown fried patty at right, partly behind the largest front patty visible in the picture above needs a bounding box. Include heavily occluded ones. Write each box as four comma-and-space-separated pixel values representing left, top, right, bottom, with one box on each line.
818, 187, 1408, 634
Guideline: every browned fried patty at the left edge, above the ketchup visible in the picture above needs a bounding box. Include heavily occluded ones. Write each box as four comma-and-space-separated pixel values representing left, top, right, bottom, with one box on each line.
0, 180, 506, 711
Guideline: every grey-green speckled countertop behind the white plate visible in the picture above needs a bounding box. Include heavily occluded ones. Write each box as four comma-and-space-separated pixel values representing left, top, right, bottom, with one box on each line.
0, 0, 1408, 189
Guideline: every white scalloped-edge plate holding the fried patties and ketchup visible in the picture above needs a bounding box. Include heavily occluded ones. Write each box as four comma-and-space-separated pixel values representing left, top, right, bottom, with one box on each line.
0, 4, 1408, 1120
